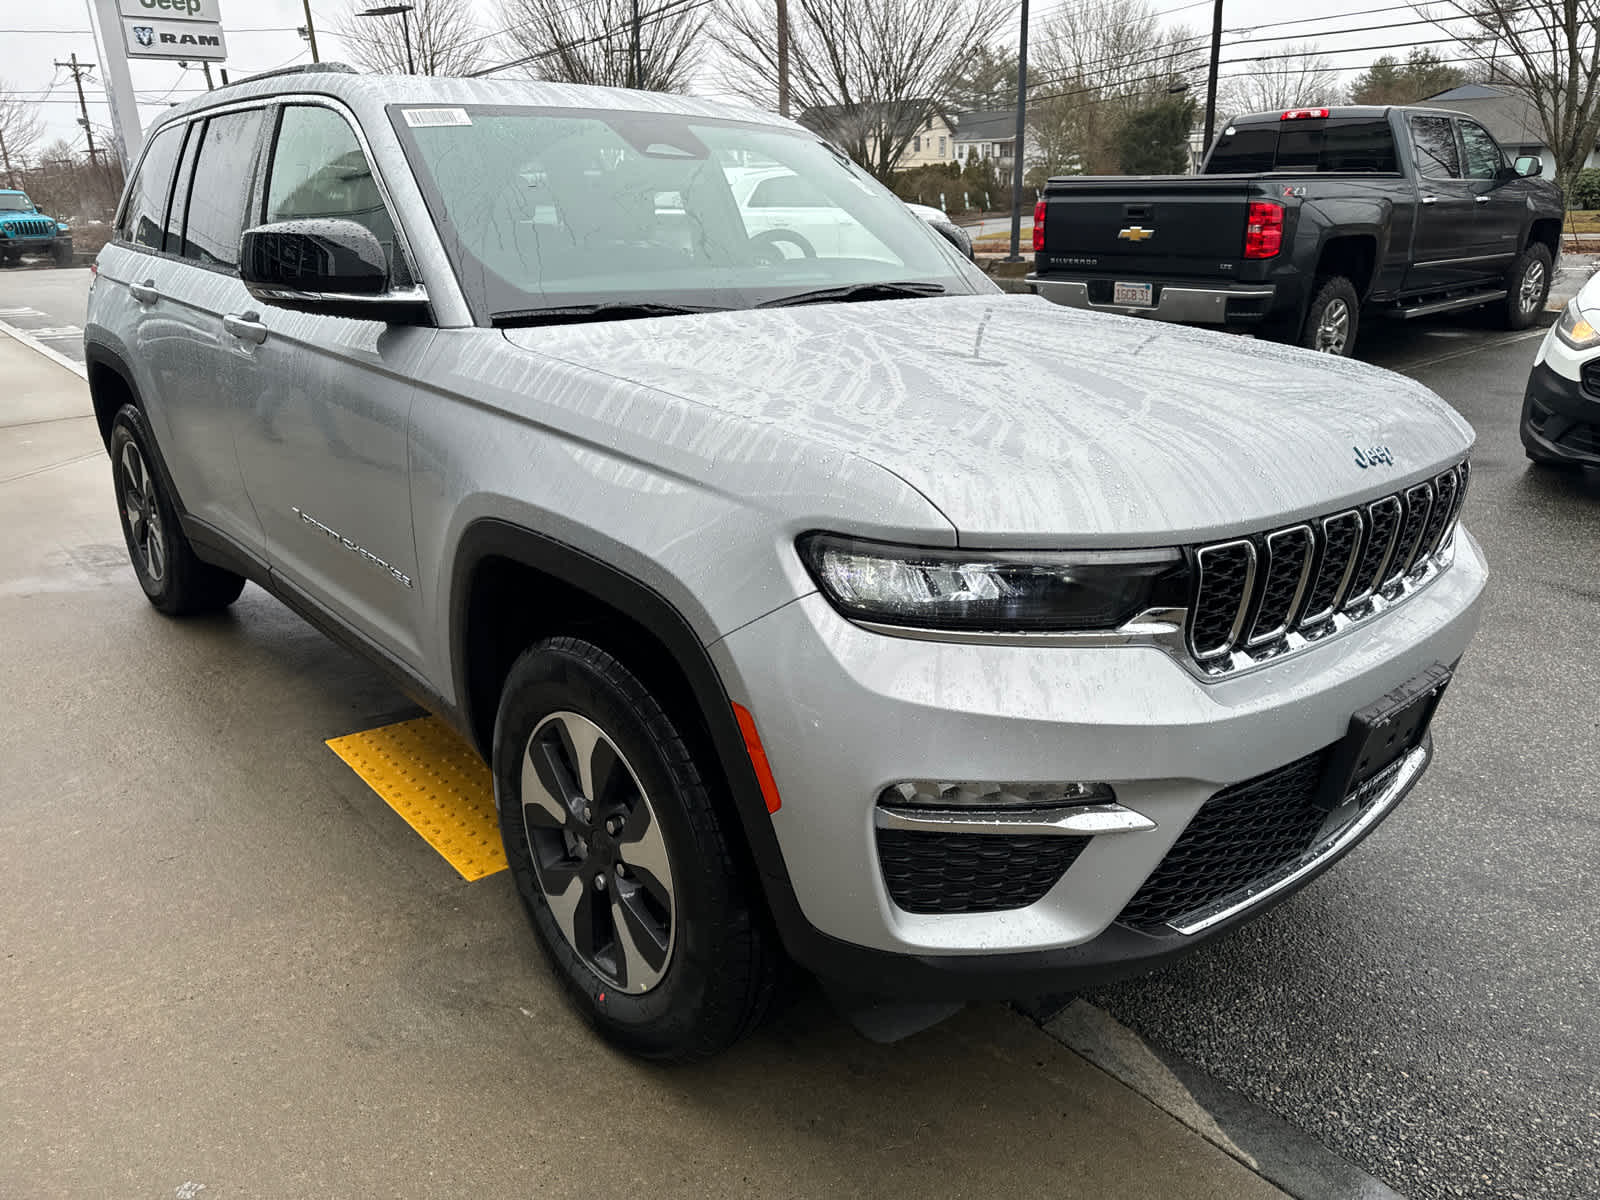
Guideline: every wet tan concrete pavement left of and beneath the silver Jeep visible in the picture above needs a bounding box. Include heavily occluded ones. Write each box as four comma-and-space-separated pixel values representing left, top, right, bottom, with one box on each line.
0, 334, 1282, 1200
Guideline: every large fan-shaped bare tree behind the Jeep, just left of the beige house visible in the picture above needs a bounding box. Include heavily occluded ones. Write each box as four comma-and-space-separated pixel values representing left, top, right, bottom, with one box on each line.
717, 0, 1010, 179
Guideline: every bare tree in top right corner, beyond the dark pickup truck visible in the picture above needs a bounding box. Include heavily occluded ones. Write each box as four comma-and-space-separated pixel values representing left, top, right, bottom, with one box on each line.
1416, 0, 1600, 187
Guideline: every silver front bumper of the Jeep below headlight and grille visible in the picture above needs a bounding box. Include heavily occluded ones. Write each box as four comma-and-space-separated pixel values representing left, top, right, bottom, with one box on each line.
712, 531, 1486, 997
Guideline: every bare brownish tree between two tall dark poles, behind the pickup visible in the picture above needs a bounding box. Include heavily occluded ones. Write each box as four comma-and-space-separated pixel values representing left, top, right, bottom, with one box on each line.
1029, 0, 1208, 179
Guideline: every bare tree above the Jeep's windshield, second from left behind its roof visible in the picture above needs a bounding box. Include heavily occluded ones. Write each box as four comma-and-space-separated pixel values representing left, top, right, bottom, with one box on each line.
499, 0, 710, 91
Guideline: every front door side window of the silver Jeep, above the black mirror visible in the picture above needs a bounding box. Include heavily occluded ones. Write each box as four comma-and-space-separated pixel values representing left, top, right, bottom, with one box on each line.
267, 104, 395, 269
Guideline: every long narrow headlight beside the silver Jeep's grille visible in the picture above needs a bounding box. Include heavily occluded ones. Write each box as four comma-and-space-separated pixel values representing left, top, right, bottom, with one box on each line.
800, 533, 1189, 634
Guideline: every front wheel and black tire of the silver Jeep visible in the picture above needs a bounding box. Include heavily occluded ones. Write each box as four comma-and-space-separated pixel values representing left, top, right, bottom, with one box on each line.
493, 637, 782, 1062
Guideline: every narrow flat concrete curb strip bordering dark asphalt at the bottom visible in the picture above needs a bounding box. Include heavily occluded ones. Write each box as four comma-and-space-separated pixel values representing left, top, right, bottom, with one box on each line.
1021, 998, 1405, 1200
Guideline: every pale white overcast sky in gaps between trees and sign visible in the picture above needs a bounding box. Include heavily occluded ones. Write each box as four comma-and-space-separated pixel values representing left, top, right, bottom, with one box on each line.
0, 0, 1472, 157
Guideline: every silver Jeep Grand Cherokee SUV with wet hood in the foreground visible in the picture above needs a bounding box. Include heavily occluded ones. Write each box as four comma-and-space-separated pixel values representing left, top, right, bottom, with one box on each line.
86, 69, 1485, 1059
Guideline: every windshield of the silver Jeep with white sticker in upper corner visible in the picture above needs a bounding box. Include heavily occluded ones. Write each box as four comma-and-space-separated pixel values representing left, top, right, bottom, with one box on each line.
390, 106, 976, 322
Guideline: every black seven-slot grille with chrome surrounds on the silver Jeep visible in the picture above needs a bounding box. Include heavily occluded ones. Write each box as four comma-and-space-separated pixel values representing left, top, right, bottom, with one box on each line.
1186, 461, 1470, 675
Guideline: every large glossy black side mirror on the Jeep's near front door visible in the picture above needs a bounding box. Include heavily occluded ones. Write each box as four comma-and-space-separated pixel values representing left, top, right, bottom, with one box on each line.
238, 218, 430, 325
